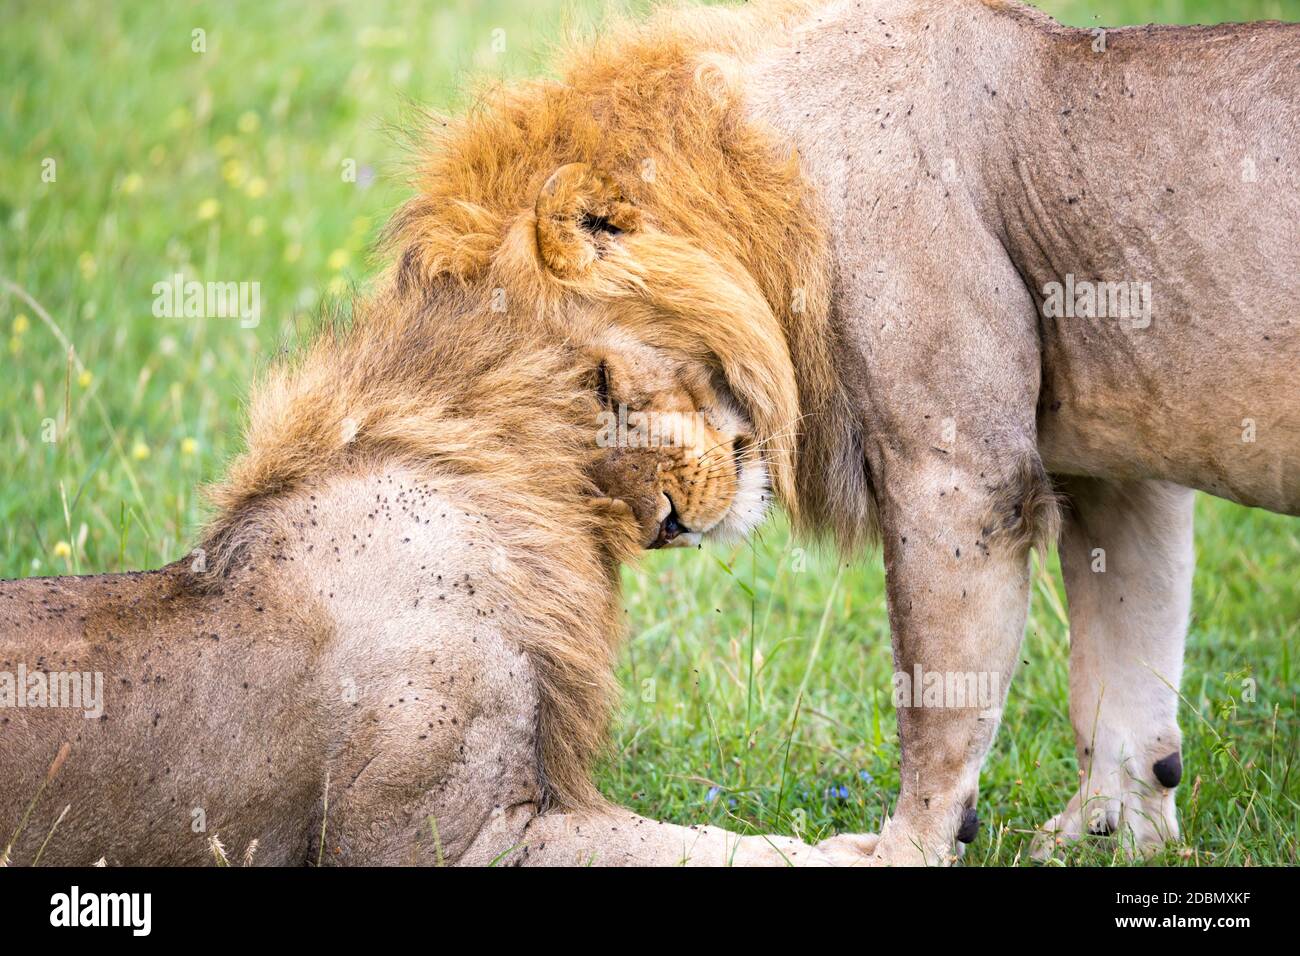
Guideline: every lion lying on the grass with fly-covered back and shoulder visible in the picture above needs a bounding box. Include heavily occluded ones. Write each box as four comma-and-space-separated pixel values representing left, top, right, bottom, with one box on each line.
0, 284, 863, 866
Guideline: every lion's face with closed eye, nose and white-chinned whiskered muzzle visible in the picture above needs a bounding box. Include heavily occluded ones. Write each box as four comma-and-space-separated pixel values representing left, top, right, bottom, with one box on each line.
585, 337, 770, 548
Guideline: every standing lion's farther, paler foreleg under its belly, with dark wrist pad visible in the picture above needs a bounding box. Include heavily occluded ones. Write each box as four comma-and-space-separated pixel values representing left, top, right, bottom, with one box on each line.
1034, 479, 1193, 860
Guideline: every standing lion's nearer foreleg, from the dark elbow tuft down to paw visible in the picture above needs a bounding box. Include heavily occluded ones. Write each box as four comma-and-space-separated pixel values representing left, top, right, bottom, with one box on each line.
874, 459, 1041, 865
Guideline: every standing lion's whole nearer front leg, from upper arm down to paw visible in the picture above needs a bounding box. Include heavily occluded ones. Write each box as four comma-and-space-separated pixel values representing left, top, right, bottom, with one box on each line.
821, 213, 1057, 864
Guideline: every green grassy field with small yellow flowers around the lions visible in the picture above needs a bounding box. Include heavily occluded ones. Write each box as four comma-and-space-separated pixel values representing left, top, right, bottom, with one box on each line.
0, 0, 1300, 865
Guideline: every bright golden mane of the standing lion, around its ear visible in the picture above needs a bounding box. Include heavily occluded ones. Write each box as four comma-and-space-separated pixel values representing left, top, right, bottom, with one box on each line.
386, 1, 875, 551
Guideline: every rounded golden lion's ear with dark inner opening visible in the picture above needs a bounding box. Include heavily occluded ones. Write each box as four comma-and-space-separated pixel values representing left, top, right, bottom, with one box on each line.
536, 163, 641, 278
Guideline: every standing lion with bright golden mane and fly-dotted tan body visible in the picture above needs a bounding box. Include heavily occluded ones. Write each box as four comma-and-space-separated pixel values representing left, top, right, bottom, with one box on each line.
387, 0, 1300, 864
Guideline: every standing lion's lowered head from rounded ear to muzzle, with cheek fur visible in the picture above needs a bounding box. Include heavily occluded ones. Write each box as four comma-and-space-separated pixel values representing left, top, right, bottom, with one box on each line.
501, 163, 805, 548
